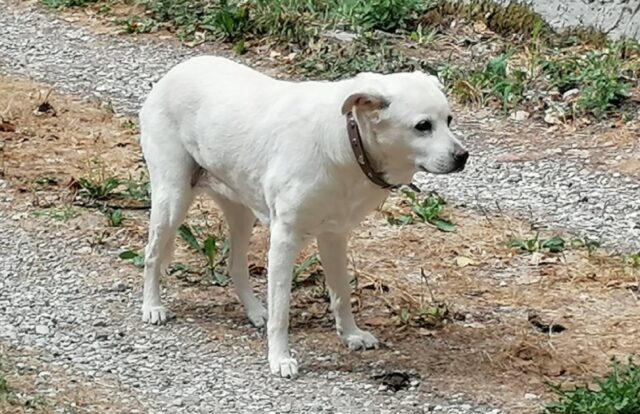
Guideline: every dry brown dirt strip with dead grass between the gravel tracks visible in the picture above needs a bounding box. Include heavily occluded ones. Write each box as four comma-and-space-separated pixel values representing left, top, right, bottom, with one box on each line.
0, 76, 640, 413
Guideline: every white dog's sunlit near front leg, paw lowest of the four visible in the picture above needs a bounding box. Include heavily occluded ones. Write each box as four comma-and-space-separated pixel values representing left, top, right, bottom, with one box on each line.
267, 222, 302, 378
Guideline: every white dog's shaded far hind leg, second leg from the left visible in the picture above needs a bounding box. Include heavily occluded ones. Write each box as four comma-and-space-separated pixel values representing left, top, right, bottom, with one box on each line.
213, 195, 267, 328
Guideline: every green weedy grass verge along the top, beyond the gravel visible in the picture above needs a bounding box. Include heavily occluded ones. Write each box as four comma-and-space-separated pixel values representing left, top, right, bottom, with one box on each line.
43, 0, 640, 123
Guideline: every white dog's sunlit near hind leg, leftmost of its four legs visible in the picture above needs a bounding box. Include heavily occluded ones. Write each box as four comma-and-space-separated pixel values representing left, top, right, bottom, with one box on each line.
142, 130, 198, 324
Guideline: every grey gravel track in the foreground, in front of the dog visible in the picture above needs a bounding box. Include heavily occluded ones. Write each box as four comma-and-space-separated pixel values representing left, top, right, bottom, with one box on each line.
0, 188, 502, 414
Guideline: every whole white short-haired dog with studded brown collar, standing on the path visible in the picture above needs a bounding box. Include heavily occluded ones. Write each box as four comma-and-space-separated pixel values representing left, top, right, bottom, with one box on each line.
140, 56, 468, 377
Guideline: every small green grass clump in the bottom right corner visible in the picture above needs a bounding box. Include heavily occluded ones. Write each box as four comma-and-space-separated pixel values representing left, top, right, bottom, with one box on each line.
544, 360, 640, 414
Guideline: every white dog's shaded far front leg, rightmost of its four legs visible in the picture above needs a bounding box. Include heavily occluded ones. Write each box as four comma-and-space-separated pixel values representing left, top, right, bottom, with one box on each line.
318, 233, 378, 349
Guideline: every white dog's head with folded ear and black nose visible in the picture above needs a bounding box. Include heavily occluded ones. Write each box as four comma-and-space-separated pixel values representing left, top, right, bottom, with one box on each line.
342, 72, 469, 182
